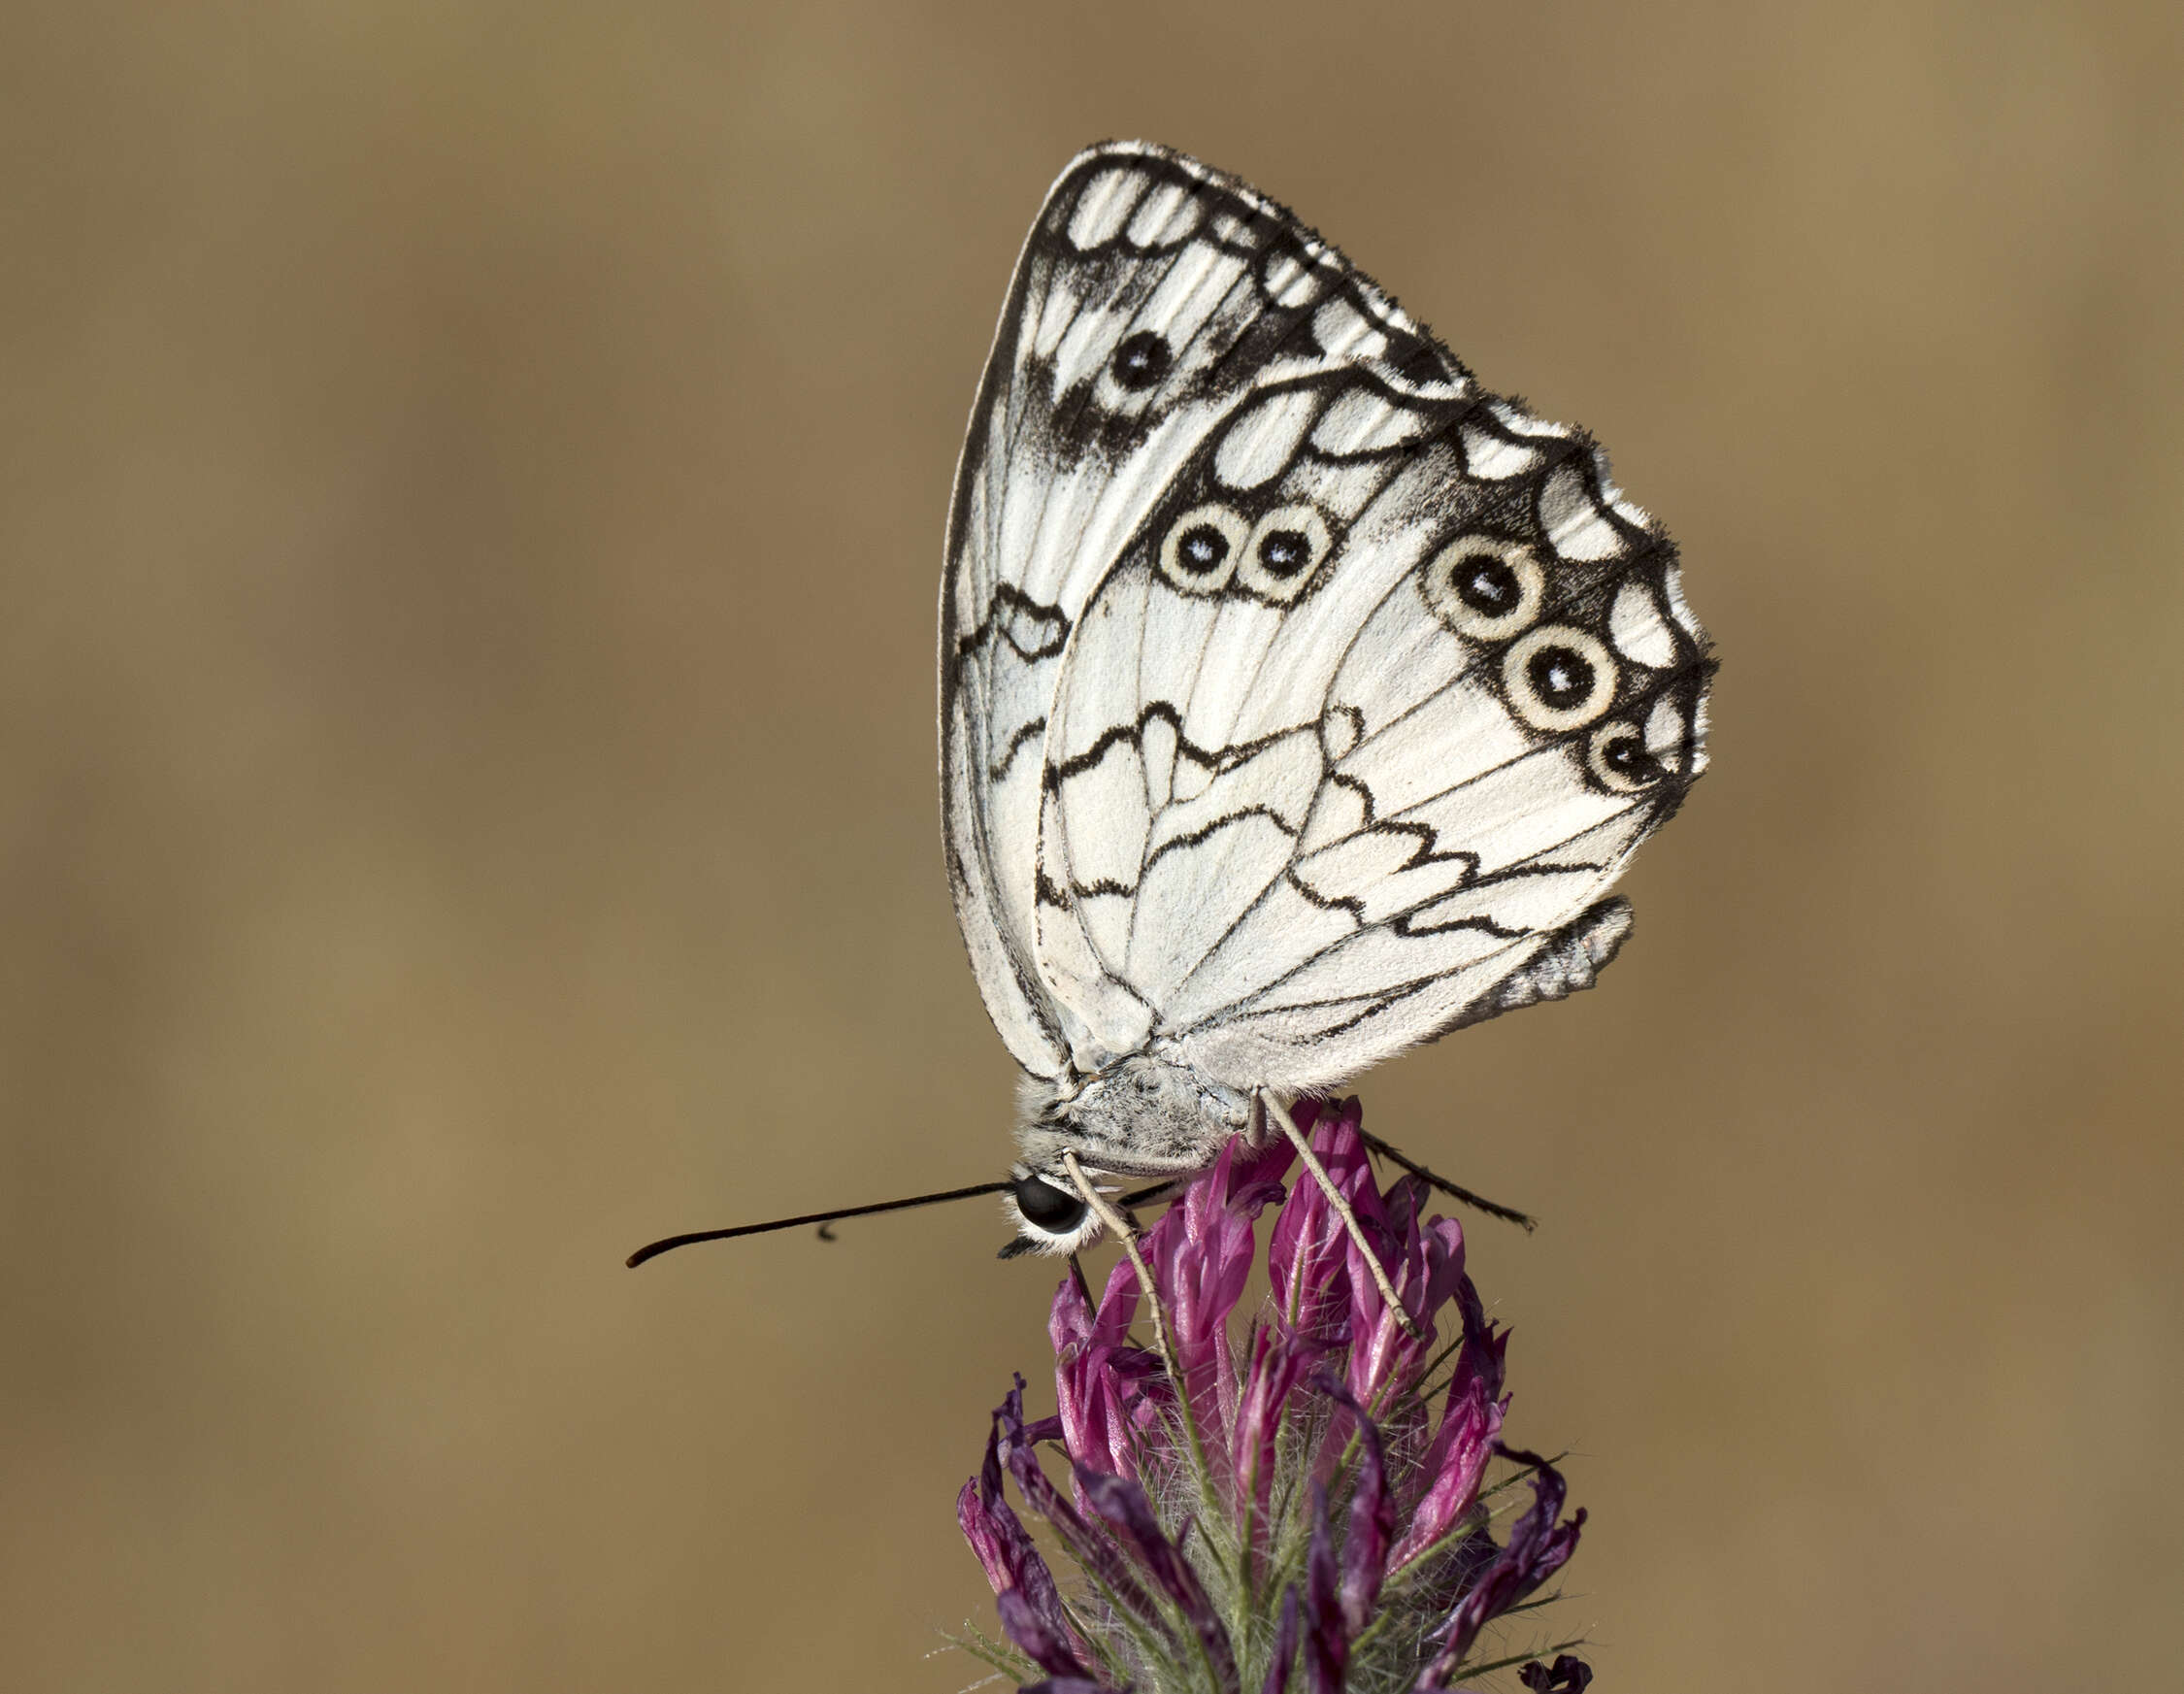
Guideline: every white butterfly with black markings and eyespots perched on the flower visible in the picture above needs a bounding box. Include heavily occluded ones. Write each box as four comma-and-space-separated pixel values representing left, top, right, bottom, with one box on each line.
940, 142, 1712, 1253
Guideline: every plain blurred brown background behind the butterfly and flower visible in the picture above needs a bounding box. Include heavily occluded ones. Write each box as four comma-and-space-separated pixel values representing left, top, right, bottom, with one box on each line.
0, 0, 2184, 1694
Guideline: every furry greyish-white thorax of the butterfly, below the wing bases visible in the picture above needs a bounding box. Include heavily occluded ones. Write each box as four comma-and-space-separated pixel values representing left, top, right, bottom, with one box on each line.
1015, 1054, 1251, 1177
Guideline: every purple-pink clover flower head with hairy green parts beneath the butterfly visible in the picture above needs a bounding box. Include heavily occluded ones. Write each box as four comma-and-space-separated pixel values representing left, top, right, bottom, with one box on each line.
957, 1100, 1592, 1694
